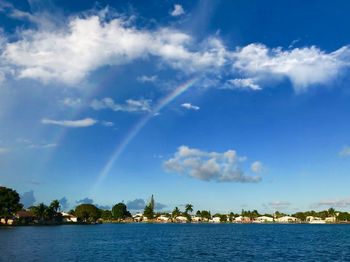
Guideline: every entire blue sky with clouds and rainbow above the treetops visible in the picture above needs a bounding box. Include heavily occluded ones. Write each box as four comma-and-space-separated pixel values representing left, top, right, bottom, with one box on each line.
0, 0, 350, 213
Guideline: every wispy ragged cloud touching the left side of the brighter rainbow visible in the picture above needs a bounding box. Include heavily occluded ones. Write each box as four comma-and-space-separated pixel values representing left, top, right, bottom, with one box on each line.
91, 97, 151, 112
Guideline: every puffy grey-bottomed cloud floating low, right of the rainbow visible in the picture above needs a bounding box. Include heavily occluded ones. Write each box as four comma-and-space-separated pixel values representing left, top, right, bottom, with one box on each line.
164, 146, 261, 183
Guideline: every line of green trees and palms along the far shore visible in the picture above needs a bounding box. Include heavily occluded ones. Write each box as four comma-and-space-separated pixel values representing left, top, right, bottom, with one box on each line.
0, 186, 350, 223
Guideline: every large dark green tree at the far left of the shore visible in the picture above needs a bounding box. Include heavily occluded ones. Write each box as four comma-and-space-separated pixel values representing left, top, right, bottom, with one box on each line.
0, 186, 23, 218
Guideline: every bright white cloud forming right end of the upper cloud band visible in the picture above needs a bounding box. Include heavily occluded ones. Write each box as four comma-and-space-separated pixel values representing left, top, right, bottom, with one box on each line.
232, 44, 350, 92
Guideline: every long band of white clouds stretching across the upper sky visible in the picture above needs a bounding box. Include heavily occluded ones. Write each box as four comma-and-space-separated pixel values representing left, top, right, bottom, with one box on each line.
0, 5, 350, 93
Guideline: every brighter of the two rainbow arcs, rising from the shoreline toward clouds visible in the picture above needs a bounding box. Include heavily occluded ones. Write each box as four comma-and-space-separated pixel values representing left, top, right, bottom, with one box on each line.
96, 77, 199, 187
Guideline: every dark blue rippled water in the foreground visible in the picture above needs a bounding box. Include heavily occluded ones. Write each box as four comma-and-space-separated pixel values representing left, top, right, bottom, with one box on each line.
0, 224, 350, 261
